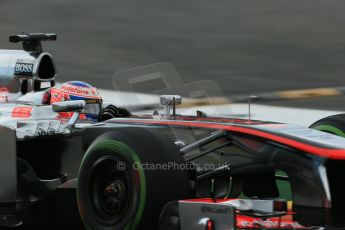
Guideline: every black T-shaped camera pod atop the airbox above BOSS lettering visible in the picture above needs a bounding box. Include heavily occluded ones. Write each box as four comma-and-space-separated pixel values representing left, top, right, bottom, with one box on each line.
9, 33, 57, 52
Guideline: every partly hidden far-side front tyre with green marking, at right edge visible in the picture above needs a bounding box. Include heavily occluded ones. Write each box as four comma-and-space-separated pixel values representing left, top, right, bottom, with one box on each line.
310, 114, 345, 137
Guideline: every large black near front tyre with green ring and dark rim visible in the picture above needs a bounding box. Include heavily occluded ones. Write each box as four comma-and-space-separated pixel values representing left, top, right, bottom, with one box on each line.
77, 128, 190, 230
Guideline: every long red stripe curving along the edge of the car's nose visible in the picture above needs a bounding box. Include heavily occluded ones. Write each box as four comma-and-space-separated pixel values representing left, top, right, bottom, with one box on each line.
112, 119, 345, 160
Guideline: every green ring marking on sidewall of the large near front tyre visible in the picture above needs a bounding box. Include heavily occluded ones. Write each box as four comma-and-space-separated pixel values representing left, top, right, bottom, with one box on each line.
77, 140, 146, 230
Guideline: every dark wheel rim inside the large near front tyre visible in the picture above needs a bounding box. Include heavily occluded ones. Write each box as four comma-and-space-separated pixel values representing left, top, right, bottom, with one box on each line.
90, 156, 132, 224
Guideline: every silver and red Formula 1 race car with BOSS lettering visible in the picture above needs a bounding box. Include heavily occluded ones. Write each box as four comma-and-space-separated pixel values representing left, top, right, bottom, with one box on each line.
0, 34, 345, 230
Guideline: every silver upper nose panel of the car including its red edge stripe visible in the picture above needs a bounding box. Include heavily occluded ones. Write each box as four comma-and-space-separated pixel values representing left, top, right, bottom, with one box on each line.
108, 119, 345, 160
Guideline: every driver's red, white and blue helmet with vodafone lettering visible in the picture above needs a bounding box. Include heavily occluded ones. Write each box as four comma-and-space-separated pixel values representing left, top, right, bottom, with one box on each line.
50, 81, 102, 121
